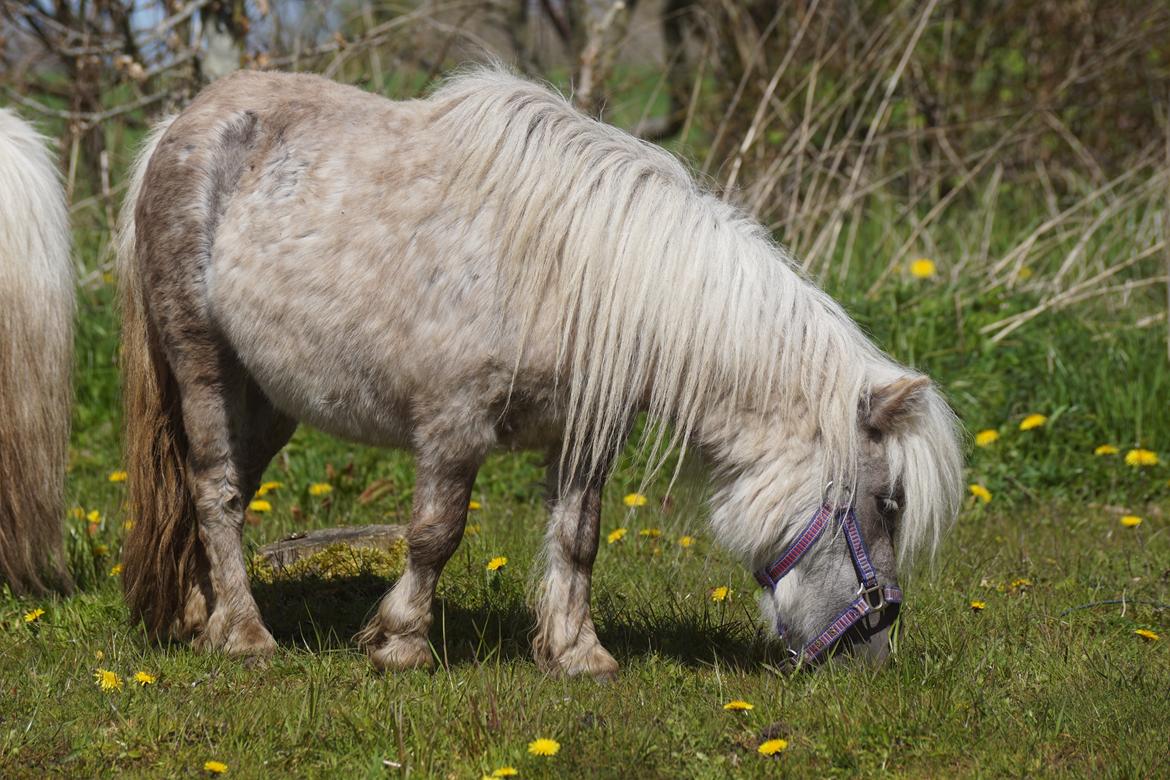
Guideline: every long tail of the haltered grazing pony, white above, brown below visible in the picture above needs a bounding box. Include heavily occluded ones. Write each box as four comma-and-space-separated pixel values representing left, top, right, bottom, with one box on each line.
117, 118, 202, 639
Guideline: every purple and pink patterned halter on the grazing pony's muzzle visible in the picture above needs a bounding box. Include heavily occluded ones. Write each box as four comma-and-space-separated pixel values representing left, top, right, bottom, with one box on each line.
756, 503, 902, 663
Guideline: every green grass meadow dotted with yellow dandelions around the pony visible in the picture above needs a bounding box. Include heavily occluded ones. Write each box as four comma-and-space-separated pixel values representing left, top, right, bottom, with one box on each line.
0, 16, 1170, 778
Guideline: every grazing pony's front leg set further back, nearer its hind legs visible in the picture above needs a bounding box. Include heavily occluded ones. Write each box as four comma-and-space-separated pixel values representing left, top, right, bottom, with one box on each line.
358, 460, 479, 670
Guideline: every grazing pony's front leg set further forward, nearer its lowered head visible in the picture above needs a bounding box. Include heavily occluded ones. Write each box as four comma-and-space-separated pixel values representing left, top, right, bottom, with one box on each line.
532, 478, 618, 679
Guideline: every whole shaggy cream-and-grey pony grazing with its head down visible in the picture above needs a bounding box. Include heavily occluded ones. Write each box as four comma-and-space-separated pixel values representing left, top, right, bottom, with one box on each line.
118, 68, 963, 677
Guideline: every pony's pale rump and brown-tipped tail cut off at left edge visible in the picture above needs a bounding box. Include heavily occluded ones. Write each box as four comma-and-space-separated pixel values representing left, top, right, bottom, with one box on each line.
0, 109, 74, 595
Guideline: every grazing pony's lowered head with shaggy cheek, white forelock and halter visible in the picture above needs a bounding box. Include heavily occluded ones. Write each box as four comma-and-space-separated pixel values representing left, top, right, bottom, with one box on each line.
713, 373, 963, 663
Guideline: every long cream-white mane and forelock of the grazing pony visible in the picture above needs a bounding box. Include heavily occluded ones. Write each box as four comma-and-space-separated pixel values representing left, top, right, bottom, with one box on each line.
431, 68, 962, 557
